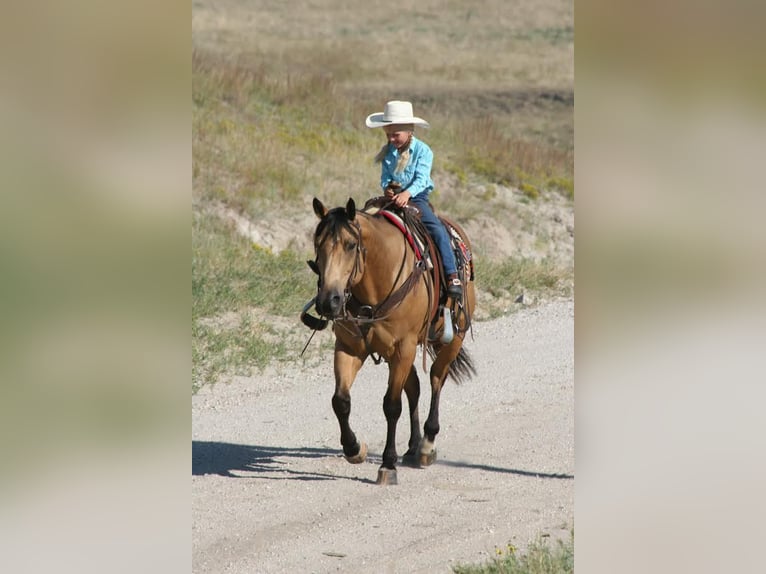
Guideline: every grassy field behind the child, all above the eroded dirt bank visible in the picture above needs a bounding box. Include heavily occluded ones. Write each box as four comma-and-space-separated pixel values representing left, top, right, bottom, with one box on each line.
192, 0, 574, 215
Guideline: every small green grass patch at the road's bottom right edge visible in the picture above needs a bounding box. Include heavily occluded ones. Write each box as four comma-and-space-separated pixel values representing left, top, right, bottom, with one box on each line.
452, 531, 574, 574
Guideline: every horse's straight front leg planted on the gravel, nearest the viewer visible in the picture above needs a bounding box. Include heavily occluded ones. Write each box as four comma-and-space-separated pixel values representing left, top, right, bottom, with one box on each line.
377, 345, 415, 484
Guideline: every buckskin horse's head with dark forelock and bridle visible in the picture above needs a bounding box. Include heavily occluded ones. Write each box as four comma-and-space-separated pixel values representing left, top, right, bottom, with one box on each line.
308, 198, 364, 318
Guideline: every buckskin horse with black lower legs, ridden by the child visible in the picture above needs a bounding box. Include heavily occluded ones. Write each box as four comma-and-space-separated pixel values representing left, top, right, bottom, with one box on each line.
302, 198, 476, 484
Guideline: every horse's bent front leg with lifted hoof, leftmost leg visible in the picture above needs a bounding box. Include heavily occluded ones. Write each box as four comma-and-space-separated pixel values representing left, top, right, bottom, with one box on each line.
332, 343, 367, 464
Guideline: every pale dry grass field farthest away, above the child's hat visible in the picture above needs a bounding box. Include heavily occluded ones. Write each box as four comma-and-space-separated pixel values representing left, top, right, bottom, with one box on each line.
192, 0, 574, 90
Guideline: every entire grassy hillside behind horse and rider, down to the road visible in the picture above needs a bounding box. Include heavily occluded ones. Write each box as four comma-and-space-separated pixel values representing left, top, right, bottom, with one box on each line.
192, 0, 574, 388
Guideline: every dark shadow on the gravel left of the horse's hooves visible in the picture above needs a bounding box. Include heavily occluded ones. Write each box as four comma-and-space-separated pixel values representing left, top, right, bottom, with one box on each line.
192, 440, 373, 483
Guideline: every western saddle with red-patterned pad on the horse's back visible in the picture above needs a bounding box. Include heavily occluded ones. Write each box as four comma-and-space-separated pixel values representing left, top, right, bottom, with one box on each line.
363, 196, 474, 330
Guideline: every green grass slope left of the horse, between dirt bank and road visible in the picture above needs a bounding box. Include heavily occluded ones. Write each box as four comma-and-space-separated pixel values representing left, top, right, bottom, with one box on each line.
192, 209, 322, 392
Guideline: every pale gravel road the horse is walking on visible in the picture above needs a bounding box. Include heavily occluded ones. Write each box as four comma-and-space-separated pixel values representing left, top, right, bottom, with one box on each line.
192, 300, 574, 574
